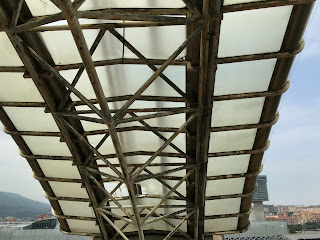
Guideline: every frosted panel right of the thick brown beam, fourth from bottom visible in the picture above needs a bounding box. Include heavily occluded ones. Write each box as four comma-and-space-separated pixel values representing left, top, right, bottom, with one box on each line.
207, 154, 251, 176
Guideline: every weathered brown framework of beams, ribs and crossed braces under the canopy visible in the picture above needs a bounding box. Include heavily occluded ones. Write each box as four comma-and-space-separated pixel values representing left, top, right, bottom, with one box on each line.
0, 0, 312, 240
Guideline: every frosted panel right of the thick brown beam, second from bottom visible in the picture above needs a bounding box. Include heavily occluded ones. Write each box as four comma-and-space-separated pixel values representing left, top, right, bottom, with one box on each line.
205, 198, 241, 216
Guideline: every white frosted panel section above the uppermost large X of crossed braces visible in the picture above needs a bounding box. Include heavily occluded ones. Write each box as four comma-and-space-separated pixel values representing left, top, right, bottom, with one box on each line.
125, 26, 186, 59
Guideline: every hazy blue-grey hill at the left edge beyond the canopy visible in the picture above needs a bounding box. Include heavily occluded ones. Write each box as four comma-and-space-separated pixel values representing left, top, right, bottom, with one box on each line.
0, 192, 51, 218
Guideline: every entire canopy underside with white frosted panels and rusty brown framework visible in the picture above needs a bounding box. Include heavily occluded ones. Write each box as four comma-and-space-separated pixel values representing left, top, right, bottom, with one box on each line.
0, 0, 313, 240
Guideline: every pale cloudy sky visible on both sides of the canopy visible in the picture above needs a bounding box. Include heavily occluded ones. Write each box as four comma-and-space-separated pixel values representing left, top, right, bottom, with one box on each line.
0, 2, 320, 205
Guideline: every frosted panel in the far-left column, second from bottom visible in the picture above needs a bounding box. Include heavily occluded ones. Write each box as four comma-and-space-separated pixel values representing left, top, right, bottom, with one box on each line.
59, 201, 95, 217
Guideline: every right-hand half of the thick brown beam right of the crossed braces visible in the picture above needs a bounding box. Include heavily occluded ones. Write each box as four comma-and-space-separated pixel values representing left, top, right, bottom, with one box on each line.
190, 0, 222, 239
